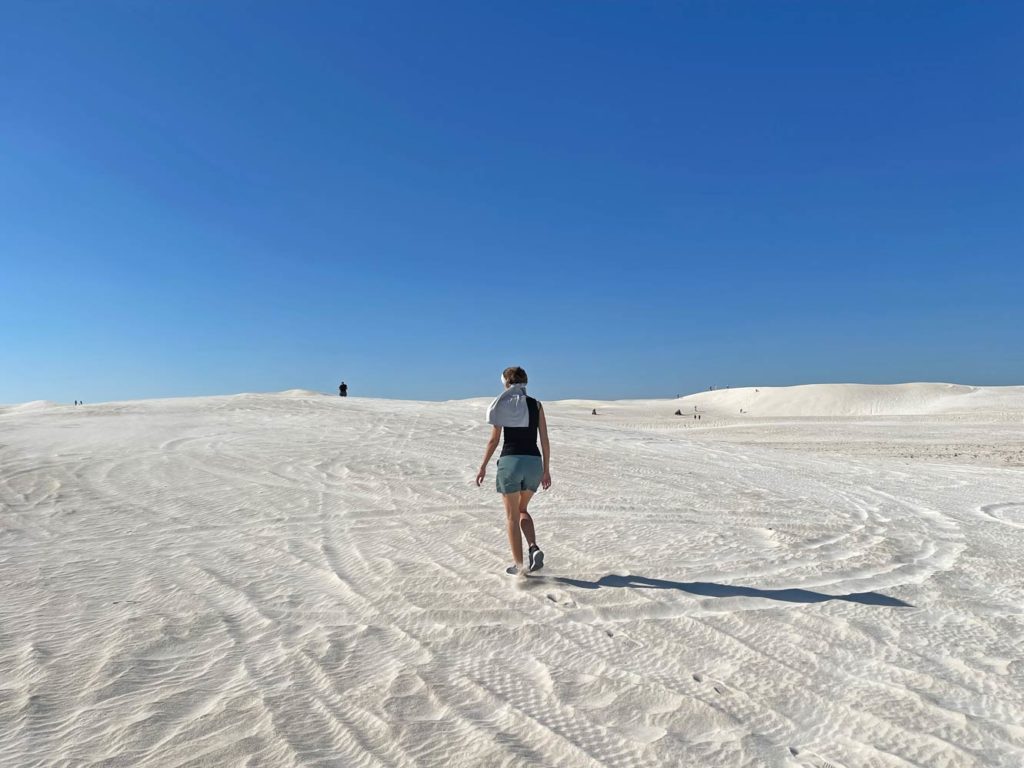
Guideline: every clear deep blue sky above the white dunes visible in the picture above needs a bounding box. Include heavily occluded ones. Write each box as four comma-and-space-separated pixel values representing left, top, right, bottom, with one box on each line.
0, 0, 1024, 402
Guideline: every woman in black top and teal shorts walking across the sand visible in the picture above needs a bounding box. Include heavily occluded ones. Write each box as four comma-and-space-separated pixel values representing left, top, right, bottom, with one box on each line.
476, 366, 551, 574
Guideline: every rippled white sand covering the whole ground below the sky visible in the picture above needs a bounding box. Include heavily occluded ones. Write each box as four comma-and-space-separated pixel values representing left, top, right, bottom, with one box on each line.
0, 384, 1024, 768
